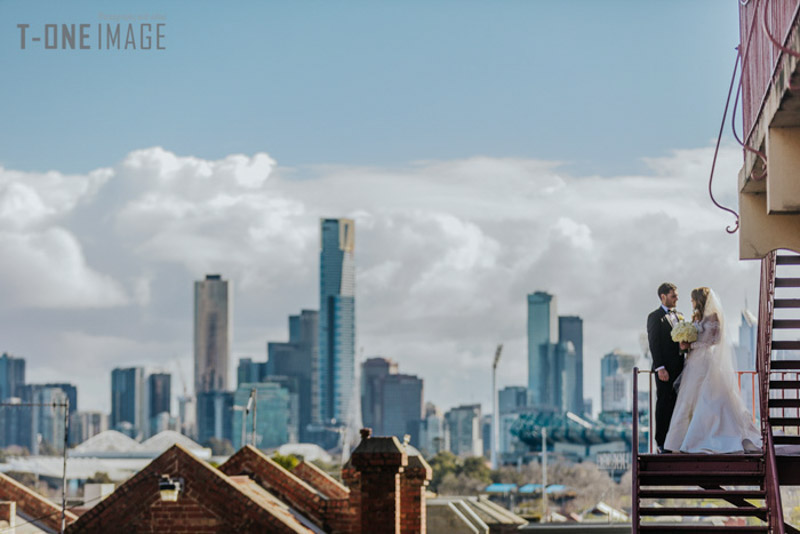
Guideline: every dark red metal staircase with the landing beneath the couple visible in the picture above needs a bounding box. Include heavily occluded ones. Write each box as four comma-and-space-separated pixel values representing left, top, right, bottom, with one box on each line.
631, 252, 800, 534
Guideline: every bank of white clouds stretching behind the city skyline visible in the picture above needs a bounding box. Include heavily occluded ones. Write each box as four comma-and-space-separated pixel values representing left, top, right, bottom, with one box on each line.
0, 148, 757, 418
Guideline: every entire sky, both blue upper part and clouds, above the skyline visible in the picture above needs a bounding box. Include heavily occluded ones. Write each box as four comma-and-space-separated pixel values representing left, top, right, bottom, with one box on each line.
0, 0, 758, 418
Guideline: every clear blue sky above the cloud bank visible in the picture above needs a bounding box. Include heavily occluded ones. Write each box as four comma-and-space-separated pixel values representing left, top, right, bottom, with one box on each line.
0, 0, 738, 174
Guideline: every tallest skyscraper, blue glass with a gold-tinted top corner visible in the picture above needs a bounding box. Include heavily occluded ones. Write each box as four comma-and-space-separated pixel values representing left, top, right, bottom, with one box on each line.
314, 219, 360, 425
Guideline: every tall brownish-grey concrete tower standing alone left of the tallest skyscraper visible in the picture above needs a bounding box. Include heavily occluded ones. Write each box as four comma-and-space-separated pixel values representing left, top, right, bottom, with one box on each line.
194, 274, 231, 394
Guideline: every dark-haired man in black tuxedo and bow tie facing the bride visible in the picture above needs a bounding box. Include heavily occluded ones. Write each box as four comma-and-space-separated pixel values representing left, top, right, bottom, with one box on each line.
647, 282, 683, 452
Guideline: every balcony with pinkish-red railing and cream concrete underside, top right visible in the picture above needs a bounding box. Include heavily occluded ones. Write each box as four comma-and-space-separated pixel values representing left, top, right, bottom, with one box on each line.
739, 0, 800, 259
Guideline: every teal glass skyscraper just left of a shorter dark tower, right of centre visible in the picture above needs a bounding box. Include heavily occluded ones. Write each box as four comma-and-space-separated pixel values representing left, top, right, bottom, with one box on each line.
528, 291, 561, 409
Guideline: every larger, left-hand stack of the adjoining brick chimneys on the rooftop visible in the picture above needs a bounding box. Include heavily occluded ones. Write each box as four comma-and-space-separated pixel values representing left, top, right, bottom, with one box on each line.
348, 428, 408, 534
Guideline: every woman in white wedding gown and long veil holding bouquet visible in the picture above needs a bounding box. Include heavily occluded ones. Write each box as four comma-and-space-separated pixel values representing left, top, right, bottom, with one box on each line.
664, 287, 761, 453
